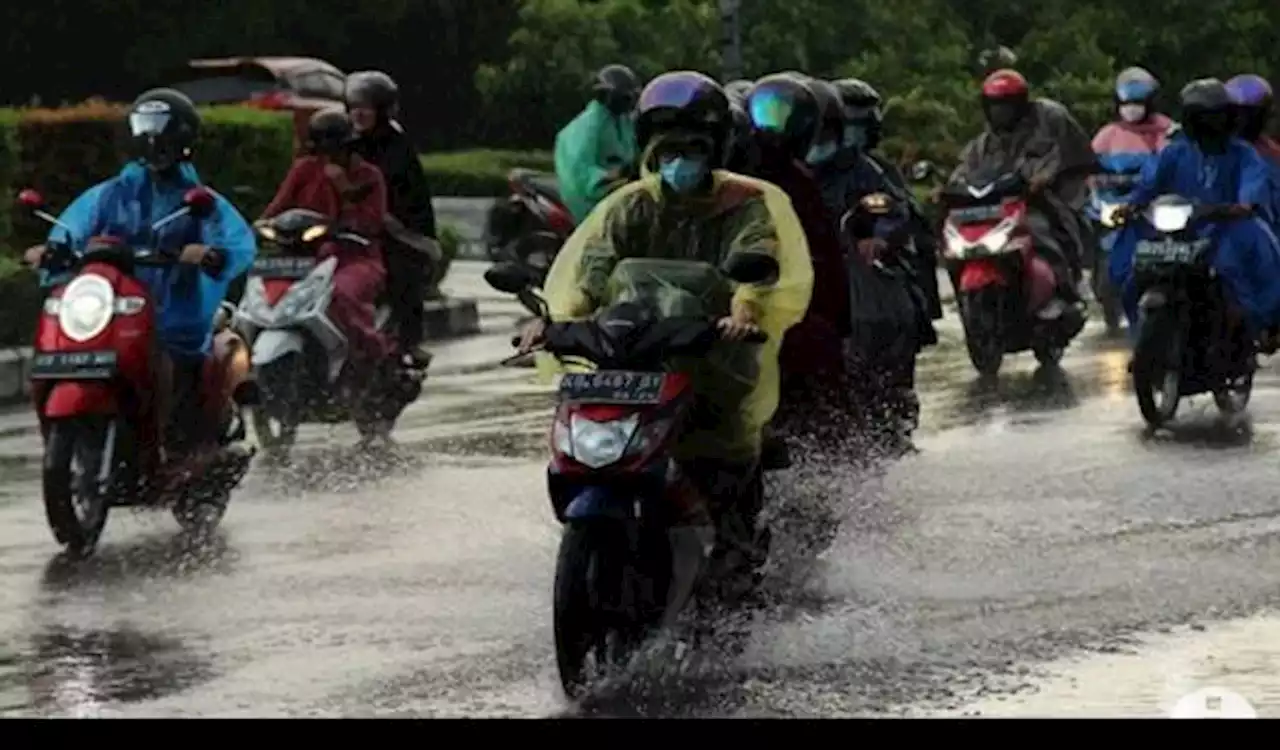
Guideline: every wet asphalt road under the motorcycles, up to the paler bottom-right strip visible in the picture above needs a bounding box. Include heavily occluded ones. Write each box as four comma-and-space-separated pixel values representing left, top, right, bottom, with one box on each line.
0, 268, 1280, 717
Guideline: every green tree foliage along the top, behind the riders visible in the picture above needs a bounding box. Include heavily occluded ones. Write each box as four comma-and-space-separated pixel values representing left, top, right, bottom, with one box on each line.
476, 0, 1280, 163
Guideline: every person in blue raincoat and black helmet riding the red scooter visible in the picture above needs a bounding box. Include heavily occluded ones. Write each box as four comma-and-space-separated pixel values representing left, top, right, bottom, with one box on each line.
26, 88, 257, 452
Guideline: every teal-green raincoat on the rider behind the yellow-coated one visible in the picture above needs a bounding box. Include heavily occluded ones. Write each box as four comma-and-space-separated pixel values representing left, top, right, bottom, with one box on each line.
556, 100, 639, 224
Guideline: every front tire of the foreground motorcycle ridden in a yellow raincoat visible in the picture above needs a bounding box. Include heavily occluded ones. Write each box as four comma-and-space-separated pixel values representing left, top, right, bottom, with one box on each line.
552, 522, 635, 700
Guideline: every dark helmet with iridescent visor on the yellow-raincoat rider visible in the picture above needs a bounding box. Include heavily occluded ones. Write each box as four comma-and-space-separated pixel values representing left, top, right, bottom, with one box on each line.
636, 70, 732, 164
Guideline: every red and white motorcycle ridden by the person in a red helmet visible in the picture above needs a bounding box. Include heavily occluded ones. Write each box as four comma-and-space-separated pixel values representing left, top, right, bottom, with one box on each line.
941, 173, 1084, 376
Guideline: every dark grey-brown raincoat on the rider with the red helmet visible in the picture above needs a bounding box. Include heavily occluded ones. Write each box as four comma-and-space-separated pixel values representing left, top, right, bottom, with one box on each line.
950, 99, 1097, 277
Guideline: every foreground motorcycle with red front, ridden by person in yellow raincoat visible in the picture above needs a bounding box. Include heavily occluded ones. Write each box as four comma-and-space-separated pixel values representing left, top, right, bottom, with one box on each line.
485, 253, 782, 698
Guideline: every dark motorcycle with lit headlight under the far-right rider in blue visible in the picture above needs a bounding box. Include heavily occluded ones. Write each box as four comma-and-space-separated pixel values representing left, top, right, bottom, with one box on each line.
1133, 195, 1257, 427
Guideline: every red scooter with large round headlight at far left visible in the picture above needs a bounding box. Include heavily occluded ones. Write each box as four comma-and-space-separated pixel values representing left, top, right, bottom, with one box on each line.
18, 188, 257, 557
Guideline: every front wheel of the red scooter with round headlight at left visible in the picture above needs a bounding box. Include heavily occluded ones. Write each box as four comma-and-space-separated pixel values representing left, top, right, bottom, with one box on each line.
42, 417, 119, 557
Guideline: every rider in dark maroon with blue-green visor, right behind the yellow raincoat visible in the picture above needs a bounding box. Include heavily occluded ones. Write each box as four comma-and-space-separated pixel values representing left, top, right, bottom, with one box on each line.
746, 73, 851, 435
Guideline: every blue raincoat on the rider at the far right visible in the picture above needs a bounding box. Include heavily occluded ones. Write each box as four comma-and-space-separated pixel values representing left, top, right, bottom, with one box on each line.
1110, 134, 1280, 331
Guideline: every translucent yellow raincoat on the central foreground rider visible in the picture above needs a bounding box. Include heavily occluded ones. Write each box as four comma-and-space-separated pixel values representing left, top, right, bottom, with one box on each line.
539, 170, 813, 461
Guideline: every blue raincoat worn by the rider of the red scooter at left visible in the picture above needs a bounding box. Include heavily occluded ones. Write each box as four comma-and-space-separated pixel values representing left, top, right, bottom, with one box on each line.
42, 163, 257, 358
